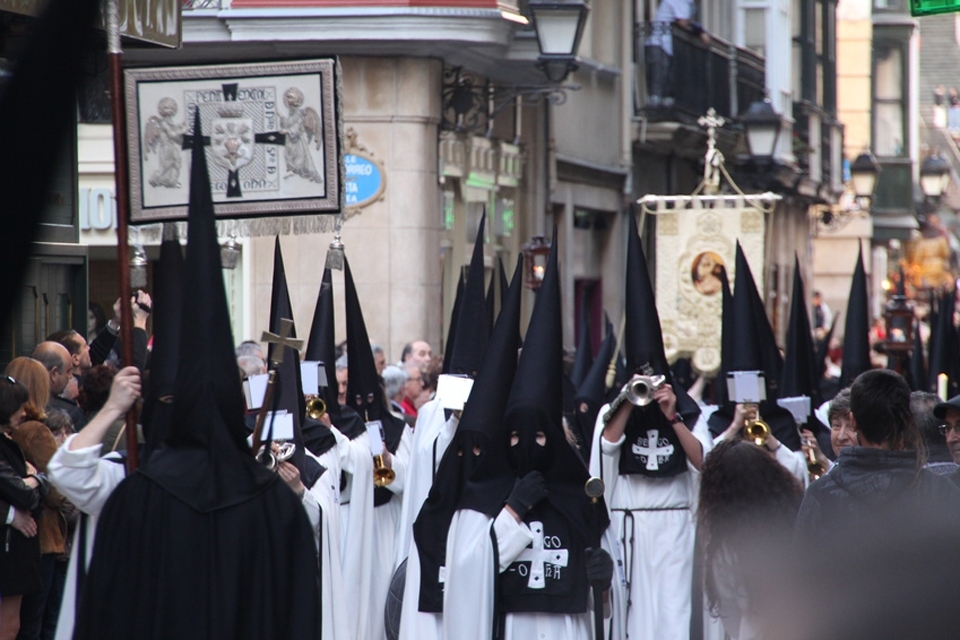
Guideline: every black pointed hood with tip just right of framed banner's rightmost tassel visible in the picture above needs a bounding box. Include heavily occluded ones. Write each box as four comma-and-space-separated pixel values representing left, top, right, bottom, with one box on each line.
343, 258, 383, 422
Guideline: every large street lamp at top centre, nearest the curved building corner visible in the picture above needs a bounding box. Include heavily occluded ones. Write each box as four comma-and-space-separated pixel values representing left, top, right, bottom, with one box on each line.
528, 0, 590, 83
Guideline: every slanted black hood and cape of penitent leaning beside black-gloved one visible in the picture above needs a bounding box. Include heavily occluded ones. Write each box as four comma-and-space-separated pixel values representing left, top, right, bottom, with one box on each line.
411, 252, 523, 612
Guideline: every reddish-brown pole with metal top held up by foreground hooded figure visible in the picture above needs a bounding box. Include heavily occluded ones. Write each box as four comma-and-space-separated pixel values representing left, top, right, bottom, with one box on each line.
106, 0, 138, 474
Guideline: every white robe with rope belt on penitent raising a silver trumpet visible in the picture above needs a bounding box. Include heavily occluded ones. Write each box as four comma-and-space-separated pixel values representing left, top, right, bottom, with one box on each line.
590, 406, 713, 640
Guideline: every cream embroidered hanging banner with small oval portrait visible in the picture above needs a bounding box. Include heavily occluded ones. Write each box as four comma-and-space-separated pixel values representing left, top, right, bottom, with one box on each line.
640, 193, 780, 376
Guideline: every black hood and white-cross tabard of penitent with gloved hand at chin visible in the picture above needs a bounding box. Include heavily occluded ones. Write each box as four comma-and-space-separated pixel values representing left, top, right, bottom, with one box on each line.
500, 233, 609, 613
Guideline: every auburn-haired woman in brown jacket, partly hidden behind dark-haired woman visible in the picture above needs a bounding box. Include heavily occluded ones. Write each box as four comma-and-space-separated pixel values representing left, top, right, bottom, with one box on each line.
5, 357, 67, 638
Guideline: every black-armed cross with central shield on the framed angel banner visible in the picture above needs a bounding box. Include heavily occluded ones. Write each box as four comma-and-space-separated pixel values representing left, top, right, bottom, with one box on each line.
183, 82, 287, 198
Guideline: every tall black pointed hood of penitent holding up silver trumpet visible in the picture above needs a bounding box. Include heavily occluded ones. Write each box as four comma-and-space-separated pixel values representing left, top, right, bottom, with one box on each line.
623, 215, 700, 428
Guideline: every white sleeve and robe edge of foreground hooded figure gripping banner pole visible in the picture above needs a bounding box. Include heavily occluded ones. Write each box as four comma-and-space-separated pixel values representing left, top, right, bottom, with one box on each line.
47, 435, 127, 640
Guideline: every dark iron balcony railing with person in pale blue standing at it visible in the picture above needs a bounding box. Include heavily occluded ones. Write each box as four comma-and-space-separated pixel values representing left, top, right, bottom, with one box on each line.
634, 22, 766, 121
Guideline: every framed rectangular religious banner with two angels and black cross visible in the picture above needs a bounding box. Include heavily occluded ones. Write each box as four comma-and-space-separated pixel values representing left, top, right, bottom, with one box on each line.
124, 58, 343, 224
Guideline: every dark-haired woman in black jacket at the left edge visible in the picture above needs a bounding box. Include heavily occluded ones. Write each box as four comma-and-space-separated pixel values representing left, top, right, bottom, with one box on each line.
0, 376, 49, 640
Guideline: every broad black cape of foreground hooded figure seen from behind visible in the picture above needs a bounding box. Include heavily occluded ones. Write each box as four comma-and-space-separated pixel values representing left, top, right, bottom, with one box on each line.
74, 462, 321, 640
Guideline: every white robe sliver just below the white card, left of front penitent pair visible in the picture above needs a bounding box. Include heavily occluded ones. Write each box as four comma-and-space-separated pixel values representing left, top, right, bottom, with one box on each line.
393, 400, 459, 571
